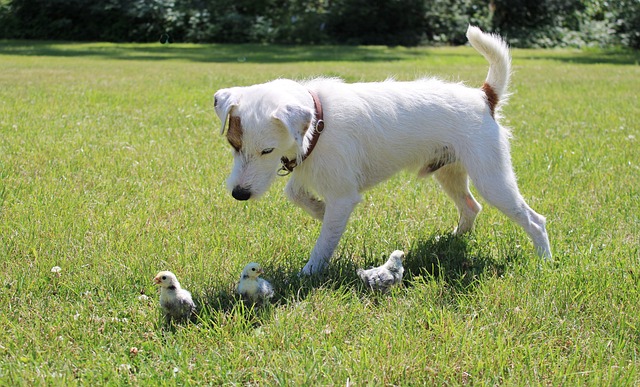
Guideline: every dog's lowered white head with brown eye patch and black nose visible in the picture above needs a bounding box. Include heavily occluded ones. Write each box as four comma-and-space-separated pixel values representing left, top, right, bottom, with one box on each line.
215, 79, 314, 200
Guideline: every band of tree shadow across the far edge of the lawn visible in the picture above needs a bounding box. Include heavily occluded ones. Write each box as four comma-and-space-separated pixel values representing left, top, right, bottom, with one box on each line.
0, 40, 640, 65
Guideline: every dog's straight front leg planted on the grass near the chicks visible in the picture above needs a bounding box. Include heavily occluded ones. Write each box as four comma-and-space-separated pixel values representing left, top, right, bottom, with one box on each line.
302, 193, 361, 275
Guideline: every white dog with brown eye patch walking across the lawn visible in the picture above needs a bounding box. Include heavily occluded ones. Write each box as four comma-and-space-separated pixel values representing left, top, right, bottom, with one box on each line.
215, 26, 551, 274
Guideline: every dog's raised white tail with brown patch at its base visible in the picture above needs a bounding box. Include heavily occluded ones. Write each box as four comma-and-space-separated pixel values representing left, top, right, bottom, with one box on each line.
467, 26, 511, 115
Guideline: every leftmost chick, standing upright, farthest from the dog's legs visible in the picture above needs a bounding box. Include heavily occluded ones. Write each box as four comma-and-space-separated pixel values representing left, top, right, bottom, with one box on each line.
153, 271, 196, 324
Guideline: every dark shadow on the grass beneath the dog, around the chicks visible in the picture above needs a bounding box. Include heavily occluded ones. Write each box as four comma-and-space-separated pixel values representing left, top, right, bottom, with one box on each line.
190, 234, 517, 327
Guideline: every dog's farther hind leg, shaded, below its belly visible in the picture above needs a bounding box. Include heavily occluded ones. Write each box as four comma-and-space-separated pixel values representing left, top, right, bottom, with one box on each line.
434, 162, 482, 235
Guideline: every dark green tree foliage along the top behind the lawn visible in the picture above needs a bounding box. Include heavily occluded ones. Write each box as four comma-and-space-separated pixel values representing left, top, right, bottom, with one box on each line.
0, 0, 640, 48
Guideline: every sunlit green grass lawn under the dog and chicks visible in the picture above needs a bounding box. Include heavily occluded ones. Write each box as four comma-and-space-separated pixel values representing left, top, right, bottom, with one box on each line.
0, 41, 640, 385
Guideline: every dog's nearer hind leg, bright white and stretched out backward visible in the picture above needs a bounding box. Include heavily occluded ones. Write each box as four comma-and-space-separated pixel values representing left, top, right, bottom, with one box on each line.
466, 152, 551, 258
